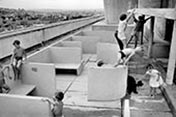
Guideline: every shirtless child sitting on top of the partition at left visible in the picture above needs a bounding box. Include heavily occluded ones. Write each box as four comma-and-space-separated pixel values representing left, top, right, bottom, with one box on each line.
11, 40, 26, 80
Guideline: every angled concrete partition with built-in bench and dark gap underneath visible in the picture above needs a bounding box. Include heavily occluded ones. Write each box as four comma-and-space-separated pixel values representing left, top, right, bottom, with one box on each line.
28, 47, 84, 75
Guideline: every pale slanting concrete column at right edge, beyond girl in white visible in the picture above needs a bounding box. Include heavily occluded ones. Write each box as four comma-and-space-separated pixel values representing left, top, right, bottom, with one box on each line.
166, 7, 176, 85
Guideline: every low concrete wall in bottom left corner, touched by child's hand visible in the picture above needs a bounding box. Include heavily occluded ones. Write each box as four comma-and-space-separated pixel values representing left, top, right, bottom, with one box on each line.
0, 94, 53, 117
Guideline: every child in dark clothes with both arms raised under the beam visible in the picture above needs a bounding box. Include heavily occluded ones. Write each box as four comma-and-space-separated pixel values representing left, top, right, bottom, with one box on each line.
127, 15, 151, 47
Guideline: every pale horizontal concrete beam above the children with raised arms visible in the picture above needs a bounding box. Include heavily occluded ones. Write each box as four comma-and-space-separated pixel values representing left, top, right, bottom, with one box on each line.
134, 8, 176, 20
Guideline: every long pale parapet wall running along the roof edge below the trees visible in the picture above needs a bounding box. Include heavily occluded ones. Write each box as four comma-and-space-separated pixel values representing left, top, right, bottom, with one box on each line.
0, 16, 103, 59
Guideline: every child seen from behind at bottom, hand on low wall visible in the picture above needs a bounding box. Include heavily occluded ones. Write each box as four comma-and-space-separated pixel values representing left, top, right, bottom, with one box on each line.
42, 92, 64, 117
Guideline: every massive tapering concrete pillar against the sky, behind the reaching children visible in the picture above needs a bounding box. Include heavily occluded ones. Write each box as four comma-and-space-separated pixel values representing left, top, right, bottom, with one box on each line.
104, 0, 137, 24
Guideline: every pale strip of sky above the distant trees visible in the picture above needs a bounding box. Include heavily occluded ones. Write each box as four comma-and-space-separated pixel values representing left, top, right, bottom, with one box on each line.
0, 0, 103, 9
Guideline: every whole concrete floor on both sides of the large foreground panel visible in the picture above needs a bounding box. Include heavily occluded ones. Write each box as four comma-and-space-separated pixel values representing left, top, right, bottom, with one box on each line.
54, 54, 172, 117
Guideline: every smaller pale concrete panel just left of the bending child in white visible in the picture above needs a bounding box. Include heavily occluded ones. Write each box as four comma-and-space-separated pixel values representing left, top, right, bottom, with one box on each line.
97, 43, 120, 64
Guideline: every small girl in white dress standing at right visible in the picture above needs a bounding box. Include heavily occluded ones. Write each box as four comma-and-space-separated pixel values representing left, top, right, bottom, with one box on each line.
146, 67, 164, 97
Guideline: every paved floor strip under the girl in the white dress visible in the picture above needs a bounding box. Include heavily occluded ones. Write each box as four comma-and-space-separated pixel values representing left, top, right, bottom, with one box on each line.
130, 74, 173, 117
